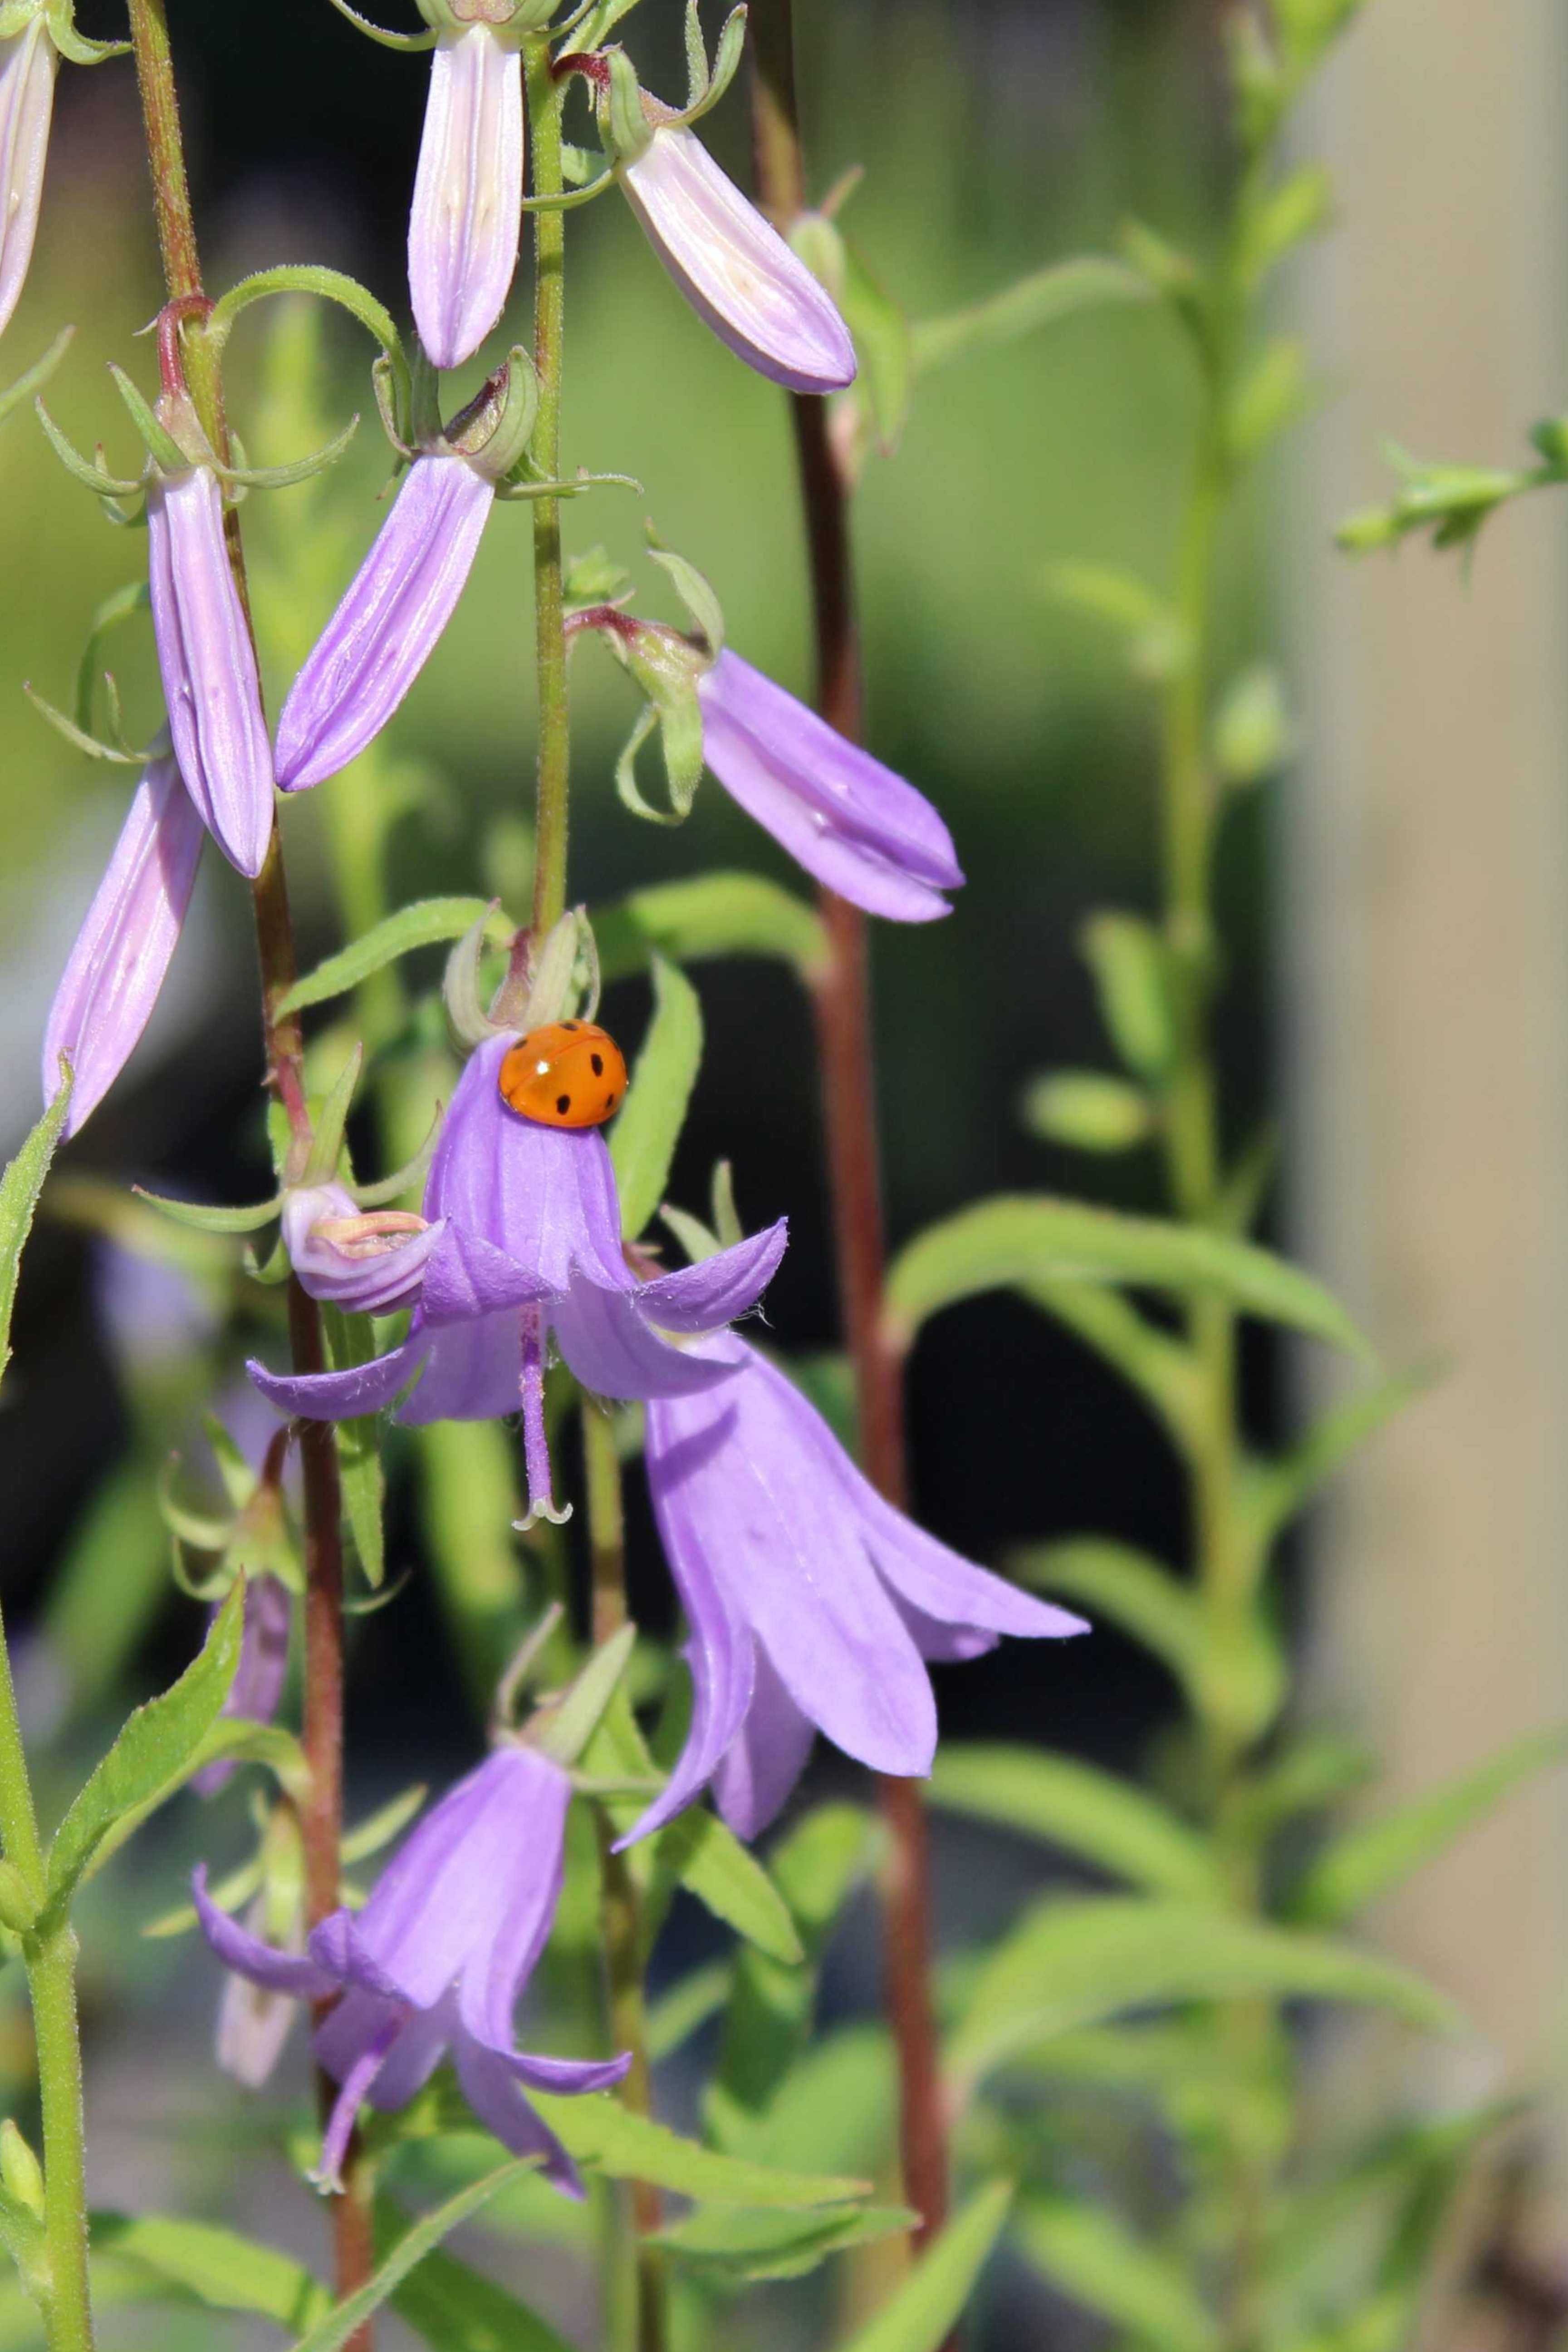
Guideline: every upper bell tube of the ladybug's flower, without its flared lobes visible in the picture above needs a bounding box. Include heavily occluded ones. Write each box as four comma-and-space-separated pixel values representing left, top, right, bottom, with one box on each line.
426, 1037, 635, 1291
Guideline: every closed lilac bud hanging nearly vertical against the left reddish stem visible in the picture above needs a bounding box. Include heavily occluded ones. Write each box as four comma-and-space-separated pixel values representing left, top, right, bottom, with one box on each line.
148, 466, 273, 880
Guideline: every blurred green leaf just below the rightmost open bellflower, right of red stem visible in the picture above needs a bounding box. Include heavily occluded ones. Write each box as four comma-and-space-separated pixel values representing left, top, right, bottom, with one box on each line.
931, 1745, 1225, 1907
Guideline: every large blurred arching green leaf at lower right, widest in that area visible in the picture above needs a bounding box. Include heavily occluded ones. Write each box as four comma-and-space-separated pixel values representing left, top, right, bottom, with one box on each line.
947, 1896, 1455, 2098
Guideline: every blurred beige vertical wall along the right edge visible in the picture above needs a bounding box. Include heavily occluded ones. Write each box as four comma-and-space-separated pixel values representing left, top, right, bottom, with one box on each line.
1281, 0, 1568, 2126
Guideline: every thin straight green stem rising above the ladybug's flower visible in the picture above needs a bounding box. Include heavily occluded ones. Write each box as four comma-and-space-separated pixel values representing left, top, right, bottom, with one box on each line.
524, 40, 571, 938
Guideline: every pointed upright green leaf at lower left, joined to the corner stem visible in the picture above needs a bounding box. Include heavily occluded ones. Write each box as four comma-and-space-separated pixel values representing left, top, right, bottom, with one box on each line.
47, 1581, 245, 1907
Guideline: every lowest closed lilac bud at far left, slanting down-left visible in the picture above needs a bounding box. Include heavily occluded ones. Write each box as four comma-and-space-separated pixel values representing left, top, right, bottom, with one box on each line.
42, 760, 202, 1136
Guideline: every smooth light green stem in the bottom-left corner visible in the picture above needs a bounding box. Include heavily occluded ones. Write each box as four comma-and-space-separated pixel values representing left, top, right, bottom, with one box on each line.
0, 1590, 94, 2352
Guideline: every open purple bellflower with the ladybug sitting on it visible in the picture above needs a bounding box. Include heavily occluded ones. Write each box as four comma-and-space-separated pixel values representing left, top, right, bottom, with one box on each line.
249, 1037, 785, 1524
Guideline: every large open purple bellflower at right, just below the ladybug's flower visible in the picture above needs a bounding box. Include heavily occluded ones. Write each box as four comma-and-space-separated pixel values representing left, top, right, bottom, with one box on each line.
632, 1338, 1086, 1837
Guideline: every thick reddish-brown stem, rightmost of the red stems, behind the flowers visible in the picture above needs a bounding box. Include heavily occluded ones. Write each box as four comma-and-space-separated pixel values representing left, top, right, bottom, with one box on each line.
752, 0, 947, 2244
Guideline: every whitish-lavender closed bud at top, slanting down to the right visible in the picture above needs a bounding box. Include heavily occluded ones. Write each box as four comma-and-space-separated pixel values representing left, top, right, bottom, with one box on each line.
621, 127, 856, 393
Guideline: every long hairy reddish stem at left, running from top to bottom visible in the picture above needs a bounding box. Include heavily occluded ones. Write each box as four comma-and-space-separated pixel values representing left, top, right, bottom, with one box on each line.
129, 0, 374, 2352
